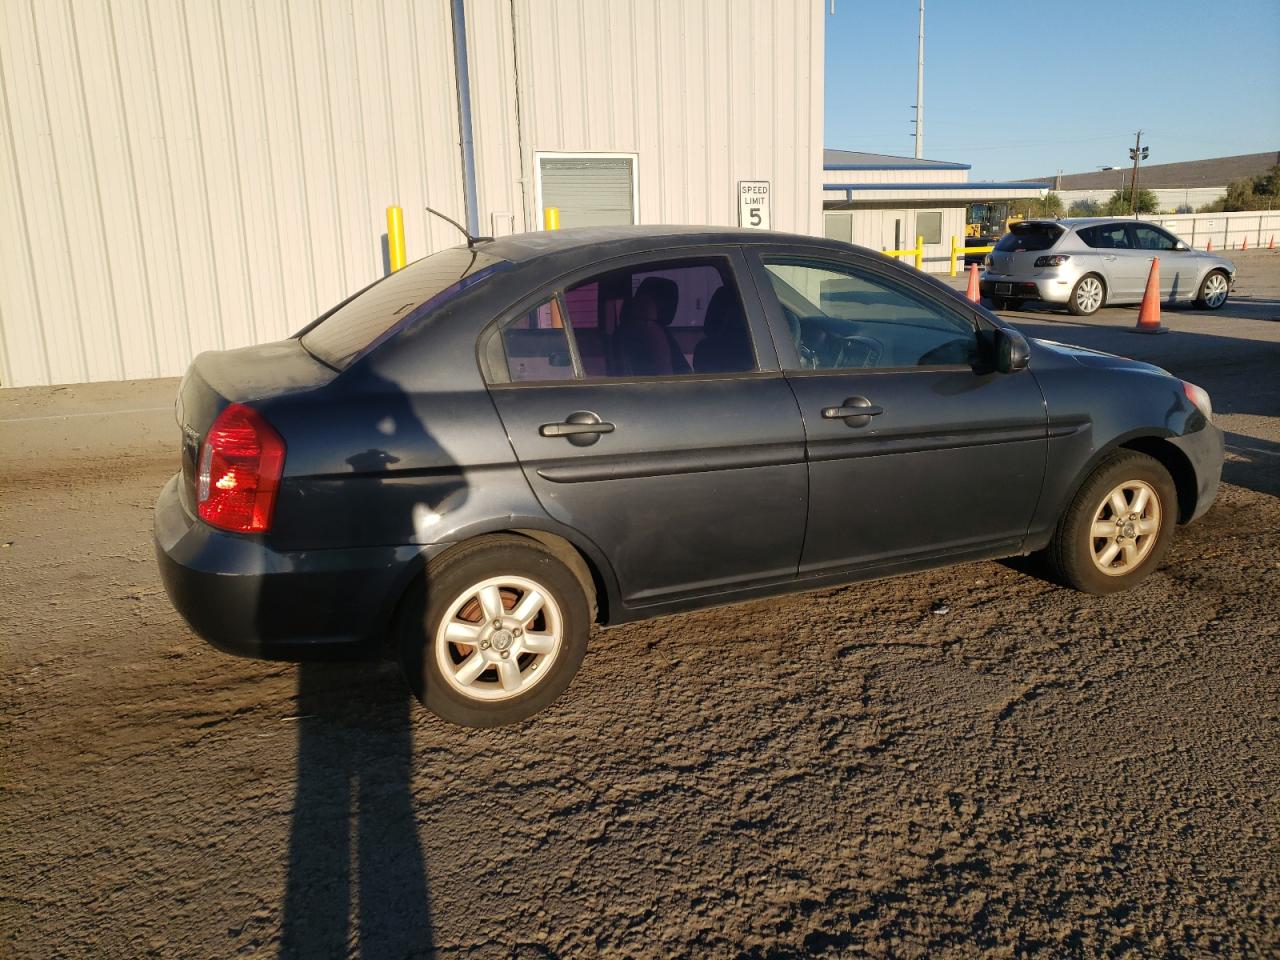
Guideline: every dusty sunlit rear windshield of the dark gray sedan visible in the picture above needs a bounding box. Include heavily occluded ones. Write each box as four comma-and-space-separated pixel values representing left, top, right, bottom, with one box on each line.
302, 247, 507, 370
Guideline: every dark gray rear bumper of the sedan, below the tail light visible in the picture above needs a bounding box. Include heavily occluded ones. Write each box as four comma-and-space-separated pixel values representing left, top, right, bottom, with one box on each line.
155, 476, 432, 660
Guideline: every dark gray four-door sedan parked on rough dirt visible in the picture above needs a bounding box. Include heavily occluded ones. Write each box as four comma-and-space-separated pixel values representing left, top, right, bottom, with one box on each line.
155, 228, 1222, 726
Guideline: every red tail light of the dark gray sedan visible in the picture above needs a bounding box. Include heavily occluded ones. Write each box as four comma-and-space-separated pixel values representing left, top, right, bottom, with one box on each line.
196, 403, 284, 534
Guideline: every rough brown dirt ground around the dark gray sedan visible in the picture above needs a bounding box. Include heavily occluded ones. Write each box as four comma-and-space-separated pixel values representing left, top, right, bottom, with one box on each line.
0, 256, 1280, 959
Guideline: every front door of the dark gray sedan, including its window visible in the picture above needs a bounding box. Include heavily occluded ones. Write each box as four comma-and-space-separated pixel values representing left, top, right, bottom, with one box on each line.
756, 252, 1047, 575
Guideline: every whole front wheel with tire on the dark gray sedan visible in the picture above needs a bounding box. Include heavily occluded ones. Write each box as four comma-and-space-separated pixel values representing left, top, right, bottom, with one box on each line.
1046, 451, 1178, 594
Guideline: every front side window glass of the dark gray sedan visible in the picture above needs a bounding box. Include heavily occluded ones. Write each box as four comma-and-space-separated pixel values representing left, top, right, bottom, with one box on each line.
764, 259, 978, 370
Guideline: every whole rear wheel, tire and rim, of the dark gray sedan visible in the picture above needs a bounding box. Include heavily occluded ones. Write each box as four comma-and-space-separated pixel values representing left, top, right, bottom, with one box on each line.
399, 536, 589, 727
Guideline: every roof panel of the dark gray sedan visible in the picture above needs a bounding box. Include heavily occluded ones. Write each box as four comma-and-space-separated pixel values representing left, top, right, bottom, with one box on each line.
465, 224, 849, 264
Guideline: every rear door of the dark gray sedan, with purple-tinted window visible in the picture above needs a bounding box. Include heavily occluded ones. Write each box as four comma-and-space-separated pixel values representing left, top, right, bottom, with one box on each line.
484, 247, 808, 605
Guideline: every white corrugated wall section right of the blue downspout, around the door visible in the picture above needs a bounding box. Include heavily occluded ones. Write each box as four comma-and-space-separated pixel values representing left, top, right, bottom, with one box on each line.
467, 0, 823, 234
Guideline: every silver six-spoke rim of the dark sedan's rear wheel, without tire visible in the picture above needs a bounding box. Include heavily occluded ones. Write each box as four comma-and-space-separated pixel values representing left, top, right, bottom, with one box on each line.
434, 576, 564, 701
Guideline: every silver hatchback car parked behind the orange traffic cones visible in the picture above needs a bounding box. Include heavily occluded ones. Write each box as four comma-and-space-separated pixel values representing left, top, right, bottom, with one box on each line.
980, 218, 1235, 316
